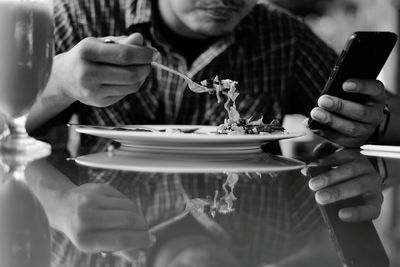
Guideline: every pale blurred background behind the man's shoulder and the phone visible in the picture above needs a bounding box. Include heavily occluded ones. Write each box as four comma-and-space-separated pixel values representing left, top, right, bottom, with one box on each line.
260, 0, 400, 92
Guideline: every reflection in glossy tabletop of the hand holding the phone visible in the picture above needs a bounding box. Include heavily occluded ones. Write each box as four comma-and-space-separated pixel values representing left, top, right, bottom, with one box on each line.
309, 144, 383, 222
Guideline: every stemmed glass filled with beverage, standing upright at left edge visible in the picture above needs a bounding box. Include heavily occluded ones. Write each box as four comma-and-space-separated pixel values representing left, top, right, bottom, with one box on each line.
0, 0, 54, 152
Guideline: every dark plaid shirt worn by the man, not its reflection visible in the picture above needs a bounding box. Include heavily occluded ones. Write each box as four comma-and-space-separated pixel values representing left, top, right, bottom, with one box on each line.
47, 0, 336, 153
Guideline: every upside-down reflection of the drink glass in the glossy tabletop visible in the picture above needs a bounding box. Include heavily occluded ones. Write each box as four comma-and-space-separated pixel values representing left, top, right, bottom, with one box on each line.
0, 152, 51, 267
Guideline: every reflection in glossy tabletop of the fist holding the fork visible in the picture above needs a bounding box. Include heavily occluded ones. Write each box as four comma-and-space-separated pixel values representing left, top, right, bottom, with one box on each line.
49, 184, 154, 253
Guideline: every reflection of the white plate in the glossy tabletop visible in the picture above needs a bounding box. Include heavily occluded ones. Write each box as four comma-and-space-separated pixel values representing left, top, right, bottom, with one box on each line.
75, 149, 305, 173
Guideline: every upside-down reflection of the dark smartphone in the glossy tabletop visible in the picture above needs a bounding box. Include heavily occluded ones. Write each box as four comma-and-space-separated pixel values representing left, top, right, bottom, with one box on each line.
308, 167, 390, 267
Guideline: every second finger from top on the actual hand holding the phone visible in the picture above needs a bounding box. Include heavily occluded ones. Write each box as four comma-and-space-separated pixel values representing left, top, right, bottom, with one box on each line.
318, 95, 383, 123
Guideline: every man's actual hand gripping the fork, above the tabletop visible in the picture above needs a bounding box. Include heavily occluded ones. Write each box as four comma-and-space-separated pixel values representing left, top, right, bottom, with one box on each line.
48, 33, 154, 107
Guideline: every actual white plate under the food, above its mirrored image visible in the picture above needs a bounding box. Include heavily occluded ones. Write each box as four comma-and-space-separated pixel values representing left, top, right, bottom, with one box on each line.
76, 125, 305, 154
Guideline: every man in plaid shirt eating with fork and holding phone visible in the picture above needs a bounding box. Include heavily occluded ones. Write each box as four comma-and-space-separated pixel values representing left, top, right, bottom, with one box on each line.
27, 0, 399, 221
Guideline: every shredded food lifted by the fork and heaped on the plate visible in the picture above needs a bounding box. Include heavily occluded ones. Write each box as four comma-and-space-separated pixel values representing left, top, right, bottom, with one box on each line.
201, 76, 286, 135
